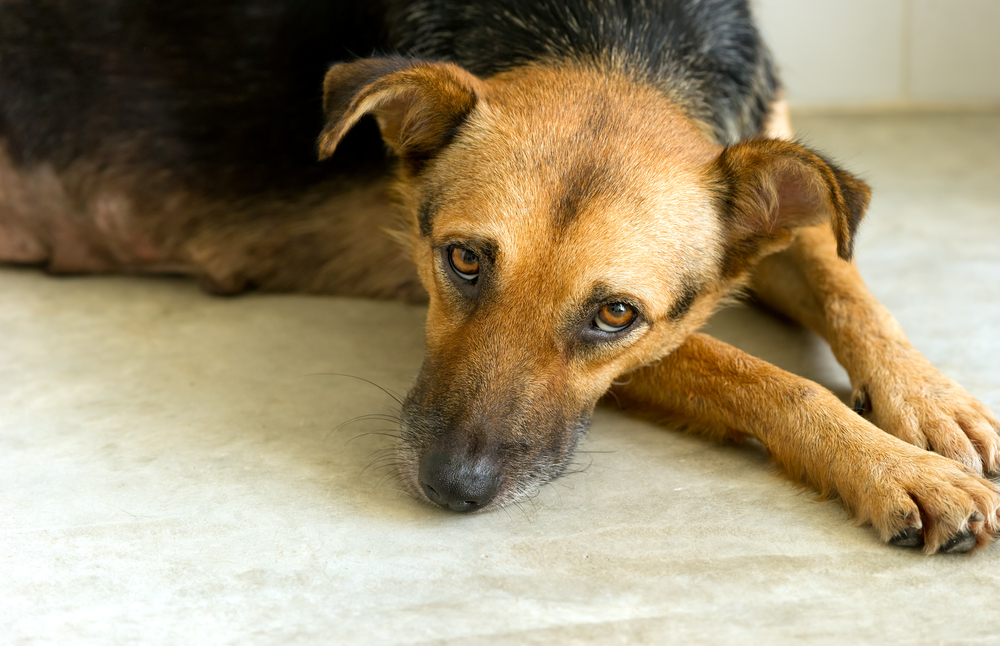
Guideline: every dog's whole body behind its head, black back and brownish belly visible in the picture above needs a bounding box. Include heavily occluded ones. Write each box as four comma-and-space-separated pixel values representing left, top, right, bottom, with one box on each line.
0, 0, 775, 298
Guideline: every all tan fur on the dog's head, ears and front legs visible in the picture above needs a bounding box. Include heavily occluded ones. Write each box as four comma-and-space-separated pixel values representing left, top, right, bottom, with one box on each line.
322, 65, 1000, 552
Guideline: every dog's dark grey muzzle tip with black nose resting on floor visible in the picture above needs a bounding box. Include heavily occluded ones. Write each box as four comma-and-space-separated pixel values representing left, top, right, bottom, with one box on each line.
396, 405, 590, 513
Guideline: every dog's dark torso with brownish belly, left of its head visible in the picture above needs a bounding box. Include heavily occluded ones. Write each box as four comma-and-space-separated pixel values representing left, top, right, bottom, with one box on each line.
0, 0, 398, 288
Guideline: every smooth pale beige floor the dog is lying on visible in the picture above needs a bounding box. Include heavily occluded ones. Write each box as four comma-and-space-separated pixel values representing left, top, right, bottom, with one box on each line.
0, 114, 1000, 645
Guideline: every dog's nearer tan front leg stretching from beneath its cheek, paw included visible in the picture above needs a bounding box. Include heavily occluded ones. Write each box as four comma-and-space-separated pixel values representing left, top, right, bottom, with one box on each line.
613, 334, 1000, 553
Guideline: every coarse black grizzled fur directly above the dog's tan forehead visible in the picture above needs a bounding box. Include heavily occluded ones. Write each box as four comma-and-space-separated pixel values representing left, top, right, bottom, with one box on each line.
389, 0, 777, 143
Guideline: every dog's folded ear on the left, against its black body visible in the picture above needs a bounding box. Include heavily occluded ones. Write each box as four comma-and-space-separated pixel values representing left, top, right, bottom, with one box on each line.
319, 57, 482, 172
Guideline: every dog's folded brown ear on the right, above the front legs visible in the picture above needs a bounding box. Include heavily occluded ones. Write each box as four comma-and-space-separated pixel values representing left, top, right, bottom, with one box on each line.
710, 139, 871, 260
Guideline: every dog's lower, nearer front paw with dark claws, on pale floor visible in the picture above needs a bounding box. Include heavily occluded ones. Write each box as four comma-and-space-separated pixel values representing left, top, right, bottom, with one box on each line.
855, 447, 1000, 554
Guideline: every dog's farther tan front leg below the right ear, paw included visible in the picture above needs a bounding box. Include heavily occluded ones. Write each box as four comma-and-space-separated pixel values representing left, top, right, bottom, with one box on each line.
753, 226, 1000, 474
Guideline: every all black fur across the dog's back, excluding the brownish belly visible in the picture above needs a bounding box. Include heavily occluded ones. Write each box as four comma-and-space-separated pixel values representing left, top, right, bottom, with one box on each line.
0, 0, 776, 195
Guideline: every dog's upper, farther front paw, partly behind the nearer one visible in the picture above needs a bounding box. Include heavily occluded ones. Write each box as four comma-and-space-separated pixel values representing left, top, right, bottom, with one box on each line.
852, 348, 1000, 475
